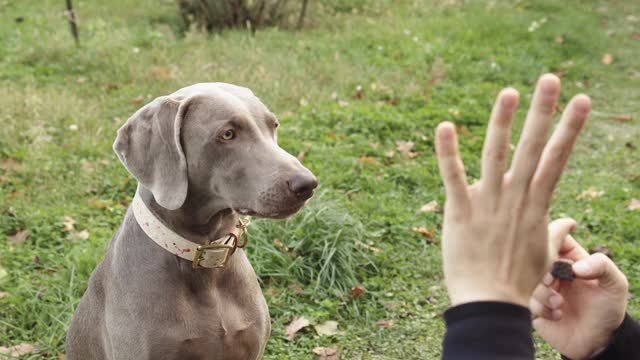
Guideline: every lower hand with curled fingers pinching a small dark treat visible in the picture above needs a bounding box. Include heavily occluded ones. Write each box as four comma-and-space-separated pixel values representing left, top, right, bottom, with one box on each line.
530, 235, 629, 359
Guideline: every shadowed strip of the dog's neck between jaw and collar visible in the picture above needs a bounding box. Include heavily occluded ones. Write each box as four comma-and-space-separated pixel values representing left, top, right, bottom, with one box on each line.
138, 186, 238, 244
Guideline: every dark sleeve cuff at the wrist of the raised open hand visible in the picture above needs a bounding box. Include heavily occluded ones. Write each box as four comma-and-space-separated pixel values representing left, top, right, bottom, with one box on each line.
442, 301, 535, 360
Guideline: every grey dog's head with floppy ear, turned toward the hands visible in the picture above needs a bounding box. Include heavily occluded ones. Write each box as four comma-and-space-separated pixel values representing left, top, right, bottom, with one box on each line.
113, 83, 317, 218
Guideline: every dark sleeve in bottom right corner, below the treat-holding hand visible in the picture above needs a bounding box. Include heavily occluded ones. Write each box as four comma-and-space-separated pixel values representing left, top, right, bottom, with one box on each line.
562, 314, 640, 360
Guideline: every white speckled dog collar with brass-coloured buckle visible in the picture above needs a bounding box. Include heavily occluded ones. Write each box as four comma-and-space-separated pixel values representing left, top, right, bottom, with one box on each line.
131, 191, 249, 269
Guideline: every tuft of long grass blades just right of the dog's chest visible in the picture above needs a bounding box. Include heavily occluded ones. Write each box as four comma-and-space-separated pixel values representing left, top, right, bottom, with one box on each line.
249, 192, 375, 294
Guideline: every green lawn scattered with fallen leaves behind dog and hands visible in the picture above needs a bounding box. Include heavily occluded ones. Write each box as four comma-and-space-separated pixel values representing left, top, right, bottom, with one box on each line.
0, 0, 640, 359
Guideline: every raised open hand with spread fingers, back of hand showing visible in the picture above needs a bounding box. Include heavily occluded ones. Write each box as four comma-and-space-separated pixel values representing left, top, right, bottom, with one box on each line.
436, 74, 591, 307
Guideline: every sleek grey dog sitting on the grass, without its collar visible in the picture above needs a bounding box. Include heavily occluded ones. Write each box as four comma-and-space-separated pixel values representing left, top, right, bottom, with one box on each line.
67, 83, 317, 360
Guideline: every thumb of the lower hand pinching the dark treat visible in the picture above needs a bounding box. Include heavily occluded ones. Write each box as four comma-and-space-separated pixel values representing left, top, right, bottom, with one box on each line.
573, 253, 629, 293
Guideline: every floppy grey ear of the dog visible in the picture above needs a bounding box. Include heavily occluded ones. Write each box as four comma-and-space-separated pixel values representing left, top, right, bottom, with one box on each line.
113, 96, 189, 210
